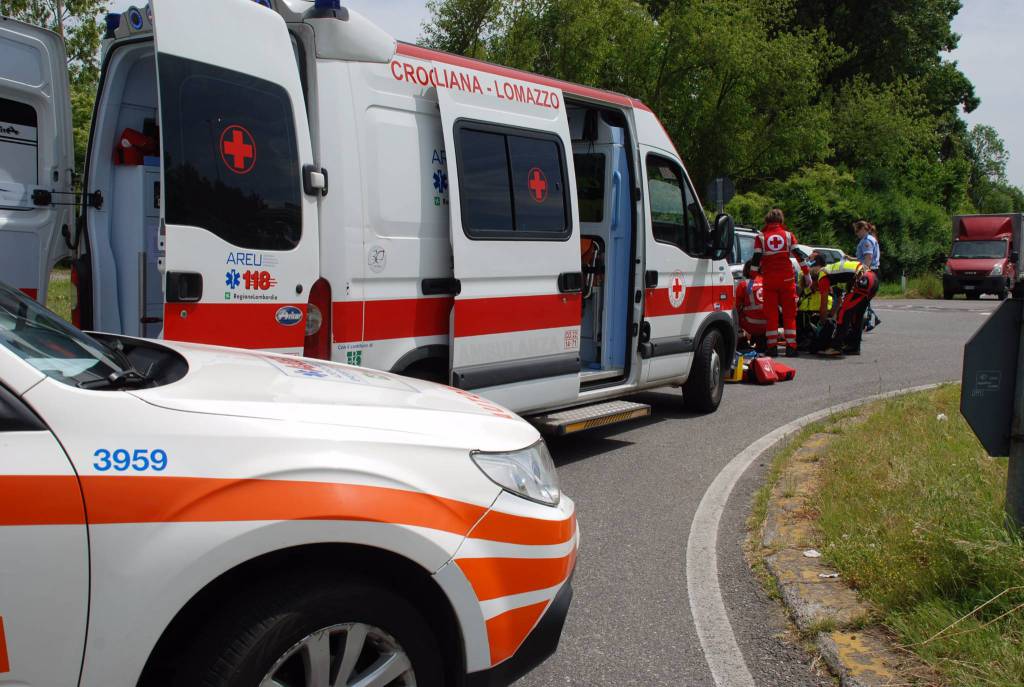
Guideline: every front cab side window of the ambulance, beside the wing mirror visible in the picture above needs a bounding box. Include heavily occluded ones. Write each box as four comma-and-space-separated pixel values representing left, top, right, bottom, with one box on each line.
647, 155, 703, 257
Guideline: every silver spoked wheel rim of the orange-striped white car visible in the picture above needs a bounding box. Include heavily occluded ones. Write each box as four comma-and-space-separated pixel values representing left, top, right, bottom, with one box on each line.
259, 622, 416, 687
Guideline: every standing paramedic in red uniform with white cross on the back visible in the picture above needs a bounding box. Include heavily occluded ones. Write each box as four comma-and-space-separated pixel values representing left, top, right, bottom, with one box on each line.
751, 208, 807, 357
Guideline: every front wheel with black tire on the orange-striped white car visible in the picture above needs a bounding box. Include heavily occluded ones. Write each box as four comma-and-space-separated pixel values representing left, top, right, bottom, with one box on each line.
162, 575, 443, 687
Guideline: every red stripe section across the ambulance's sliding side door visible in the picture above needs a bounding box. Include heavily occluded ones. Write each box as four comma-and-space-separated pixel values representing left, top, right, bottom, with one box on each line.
455, 294, 581, 337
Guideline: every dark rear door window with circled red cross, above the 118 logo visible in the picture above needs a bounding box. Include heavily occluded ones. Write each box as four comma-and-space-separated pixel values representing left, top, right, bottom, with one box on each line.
159, 53, 302, 251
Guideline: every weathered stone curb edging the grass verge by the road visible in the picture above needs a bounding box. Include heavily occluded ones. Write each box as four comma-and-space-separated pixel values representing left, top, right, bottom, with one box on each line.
760, 384, 938, 687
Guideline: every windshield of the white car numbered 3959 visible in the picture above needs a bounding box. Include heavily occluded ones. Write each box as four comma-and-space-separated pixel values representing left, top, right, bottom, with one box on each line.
0, 284, 124, 387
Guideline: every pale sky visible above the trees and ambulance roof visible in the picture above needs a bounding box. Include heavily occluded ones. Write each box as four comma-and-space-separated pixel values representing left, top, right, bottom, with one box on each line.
113, 0, 1024, 188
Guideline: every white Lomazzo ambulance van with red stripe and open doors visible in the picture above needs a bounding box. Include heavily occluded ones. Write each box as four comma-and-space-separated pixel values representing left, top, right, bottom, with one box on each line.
0, 0, 735, 432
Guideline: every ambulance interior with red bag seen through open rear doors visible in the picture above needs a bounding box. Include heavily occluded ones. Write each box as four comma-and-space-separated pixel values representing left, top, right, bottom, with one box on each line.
84, 40, 164, 337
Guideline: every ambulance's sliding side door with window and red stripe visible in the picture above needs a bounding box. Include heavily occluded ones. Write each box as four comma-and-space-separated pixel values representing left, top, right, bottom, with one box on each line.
434, 68, 582, 412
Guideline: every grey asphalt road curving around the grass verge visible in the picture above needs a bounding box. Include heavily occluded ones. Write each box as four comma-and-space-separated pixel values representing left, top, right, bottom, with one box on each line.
516, 300, 997, 687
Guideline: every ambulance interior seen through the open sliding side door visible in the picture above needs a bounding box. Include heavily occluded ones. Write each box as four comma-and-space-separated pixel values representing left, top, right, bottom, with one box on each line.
568, 105, 635, 385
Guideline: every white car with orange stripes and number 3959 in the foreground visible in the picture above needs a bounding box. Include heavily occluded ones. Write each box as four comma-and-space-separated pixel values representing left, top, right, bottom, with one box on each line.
0, 283, 579, 687
